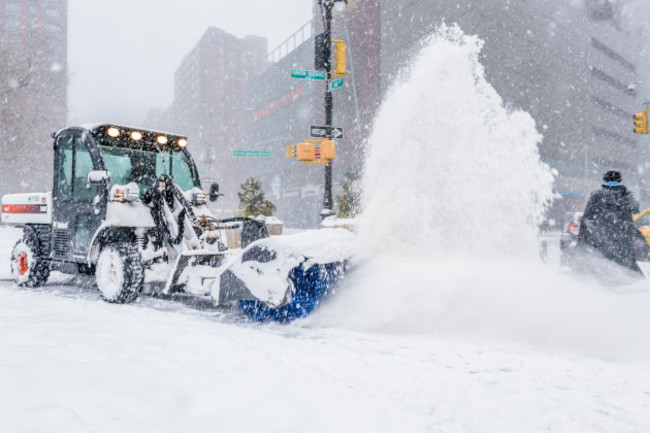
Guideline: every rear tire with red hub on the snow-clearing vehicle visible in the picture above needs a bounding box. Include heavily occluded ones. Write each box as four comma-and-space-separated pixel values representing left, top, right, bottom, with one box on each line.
11, 235, 50, 287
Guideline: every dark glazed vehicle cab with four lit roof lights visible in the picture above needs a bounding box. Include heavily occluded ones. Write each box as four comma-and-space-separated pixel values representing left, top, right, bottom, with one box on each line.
51, 125, 201, 263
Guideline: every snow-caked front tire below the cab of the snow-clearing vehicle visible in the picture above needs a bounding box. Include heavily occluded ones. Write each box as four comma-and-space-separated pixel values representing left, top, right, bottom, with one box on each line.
95, 244, 144, 304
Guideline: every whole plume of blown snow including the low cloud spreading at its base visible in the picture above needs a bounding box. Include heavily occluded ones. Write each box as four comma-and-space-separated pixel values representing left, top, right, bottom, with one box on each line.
307, 26, 650, 359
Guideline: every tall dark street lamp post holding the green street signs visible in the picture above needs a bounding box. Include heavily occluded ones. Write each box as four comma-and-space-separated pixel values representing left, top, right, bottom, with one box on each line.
318, 0, 348, 219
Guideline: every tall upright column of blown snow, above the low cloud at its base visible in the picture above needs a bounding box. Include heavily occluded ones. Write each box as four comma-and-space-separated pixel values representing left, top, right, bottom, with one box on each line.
360, 25, 553, 257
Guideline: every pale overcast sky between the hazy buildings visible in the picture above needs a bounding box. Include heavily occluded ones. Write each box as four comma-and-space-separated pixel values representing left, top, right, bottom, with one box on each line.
68, 0, 315, 125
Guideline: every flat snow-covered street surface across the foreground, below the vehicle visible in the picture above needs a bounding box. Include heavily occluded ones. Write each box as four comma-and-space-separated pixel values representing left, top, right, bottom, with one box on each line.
0, 229, 650, 432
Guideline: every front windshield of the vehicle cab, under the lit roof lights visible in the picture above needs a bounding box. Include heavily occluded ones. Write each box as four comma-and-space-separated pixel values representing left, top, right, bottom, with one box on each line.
98, 137, 200, 194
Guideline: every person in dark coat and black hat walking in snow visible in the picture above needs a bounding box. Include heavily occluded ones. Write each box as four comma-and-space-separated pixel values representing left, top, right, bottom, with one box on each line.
576, 170, 643, 277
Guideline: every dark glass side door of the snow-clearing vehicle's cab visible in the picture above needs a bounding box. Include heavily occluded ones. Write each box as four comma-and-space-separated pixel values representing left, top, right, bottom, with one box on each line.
52, 131, 106, 263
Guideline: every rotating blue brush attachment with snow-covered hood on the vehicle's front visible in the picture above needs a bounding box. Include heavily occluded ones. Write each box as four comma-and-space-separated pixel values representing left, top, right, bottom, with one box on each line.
212, 229, 354, 323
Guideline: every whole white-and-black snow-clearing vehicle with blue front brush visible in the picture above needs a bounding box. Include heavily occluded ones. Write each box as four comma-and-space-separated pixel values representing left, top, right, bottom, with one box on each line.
2, 124, 351, 321
